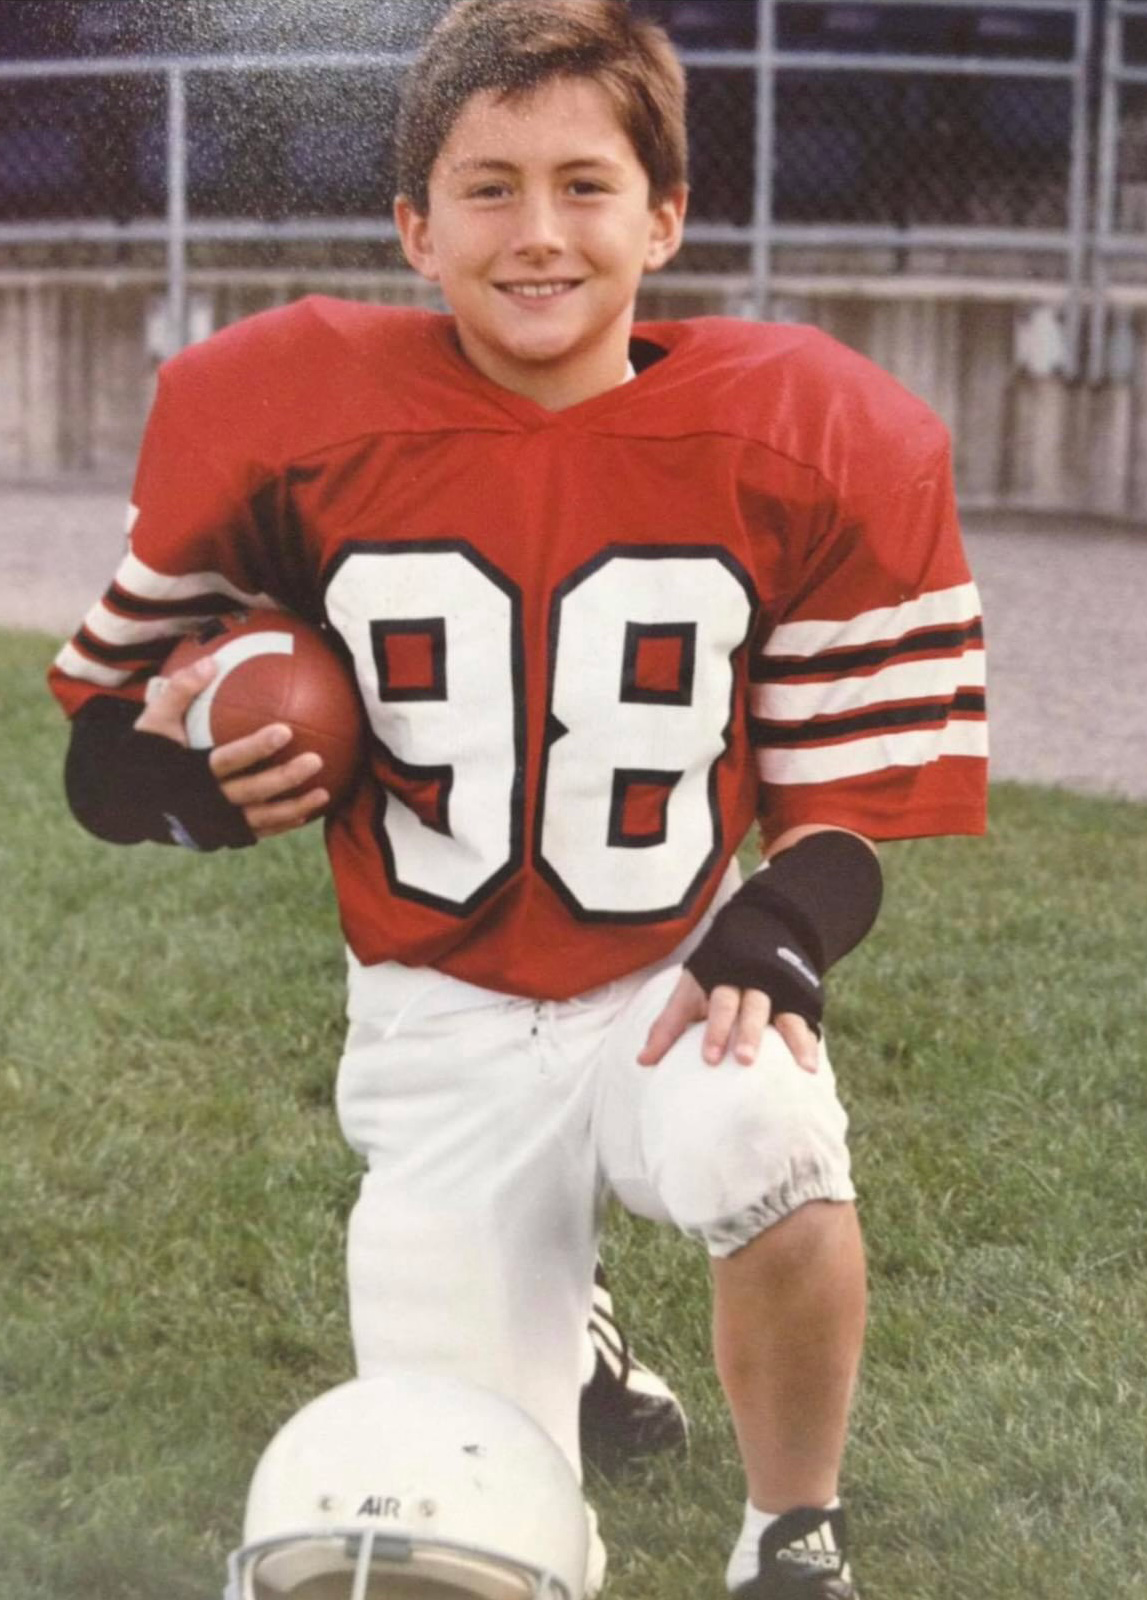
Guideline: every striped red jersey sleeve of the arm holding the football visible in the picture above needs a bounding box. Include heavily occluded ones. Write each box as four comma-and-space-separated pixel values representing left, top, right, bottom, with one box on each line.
48, 363, 290, 717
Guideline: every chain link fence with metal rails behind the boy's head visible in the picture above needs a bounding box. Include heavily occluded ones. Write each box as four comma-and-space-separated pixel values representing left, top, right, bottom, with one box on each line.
0, 0, 1126, 368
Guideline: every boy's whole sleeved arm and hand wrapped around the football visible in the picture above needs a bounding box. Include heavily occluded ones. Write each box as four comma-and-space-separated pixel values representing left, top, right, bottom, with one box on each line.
50, 339, 331, 850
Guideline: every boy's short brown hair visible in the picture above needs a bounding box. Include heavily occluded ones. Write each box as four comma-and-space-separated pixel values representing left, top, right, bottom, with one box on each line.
397, 0, 688, 216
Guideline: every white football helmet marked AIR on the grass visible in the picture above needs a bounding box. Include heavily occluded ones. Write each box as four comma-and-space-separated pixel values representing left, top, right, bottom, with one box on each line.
224, 1368, 589, 1600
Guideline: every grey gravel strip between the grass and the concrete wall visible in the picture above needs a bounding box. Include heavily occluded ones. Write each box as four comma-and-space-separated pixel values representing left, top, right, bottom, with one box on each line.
0, 485, 1147, 800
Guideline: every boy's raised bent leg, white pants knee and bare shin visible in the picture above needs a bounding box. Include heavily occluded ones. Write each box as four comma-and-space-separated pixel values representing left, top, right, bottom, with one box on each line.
597, 971, 865, 1510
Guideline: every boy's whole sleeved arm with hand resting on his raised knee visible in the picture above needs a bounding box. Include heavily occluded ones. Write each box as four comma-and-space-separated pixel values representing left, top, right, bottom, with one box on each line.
638, 366, 987, 1070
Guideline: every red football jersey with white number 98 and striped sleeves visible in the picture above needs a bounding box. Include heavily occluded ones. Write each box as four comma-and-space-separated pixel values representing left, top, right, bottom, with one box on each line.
53, 298, 985, 998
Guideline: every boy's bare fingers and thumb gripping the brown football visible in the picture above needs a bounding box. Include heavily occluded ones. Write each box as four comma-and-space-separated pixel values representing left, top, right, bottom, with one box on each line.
134, 656, 330, 838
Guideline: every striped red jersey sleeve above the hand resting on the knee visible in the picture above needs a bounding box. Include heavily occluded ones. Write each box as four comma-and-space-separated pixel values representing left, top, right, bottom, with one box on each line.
750, 406, 987, 840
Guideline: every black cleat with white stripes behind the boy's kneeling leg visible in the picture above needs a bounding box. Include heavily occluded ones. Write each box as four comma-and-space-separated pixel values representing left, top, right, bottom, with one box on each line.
581, 1267, 689, 1477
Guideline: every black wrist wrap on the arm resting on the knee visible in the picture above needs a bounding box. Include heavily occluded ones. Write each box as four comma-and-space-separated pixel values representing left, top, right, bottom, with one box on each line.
685, 829, 883, 1026
